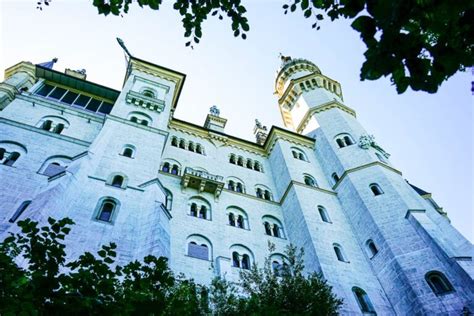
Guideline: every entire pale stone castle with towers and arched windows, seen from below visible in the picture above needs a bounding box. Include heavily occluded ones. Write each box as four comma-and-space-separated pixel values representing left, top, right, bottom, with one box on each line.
0, 56, 474, 315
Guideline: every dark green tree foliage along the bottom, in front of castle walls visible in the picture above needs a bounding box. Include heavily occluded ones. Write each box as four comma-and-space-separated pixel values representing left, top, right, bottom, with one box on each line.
0, 218, 342, 316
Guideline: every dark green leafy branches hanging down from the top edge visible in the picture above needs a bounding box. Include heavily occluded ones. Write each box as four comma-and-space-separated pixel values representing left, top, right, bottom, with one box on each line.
38, 0, 474, 93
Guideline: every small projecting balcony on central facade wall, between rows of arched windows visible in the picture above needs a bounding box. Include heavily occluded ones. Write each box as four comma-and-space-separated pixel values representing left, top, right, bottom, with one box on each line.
181, 167, 224, 198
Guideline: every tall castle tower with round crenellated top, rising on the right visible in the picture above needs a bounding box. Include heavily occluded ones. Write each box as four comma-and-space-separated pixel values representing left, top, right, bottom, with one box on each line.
275, 57, 474, 315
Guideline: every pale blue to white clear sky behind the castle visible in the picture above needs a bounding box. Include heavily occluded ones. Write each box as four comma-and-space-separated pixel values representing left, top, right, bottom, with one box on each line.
0, 0, 474, 242
